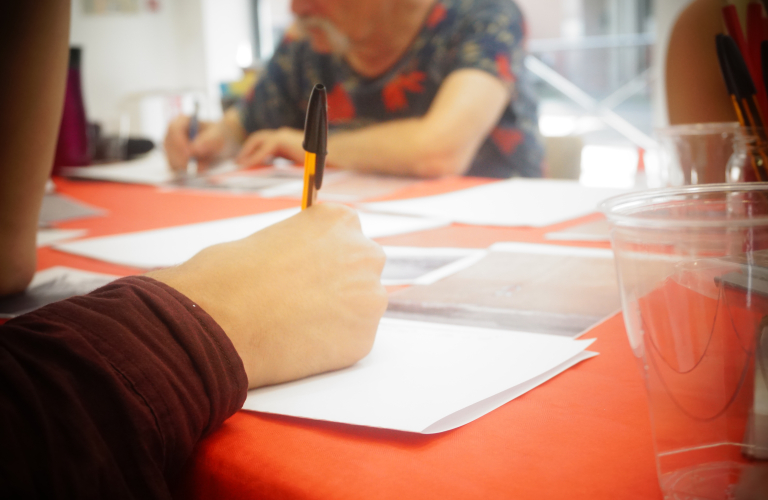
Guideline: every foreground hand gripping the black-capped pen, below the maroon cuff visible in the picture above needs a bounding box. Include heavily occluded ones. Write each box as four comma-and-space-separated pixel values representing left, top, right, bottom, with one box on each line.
148, 204, 387, 388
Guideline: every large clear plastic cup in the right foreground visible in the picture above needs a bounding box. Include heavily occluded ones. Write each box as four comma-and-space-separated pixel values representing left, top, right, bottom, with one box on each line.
601, 183, 768, 500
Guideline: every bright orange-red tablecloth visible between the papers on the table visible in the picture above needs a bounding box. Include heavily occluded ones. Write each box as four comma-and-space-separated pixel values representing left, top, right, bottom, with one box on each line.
46, 178, 662, 500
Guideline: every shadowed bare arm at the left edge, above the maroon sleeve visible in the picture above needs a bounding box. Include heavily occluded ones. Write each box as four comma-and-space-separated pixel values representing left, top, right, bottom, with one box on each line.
0, 0, 69, 296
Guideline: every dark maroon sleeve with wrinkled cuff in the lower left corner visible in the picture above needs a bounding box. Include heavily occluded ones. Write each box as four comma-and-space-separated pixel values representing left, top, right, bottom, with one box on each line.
0, 277, 247, 499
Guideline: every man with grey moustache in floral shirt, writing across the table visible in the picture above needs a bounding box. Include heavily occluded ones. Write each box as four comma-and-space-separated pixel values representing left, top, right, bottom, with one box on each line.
166, 0, 543, 178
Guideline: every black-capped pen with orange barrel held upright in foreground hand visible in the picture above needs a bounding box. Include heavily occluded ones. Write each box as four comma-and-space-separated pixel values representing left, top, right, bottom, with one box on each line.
301, 83, 328, 210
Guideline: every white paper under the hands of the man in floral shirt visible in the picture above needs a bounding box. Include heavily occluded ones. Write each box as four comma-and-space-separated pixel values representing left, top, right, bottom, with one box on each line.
62, 150, 237, 185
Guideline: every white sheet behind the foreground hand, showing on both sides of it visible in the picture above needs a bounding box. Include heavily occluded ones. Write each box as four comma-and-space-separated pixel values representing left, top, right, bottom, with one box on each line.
54, 208, 448, 269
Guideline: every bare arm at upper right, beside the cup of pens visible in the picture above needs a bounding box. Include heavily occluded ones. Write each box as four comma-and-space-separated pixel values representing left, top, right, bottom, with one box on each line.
666, 0, 736, 125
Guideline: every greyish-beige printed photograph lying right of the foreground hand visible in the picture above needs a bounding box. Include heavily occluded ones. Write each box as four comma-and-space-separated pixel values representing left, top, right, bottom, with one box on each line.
386, 243, 621, 337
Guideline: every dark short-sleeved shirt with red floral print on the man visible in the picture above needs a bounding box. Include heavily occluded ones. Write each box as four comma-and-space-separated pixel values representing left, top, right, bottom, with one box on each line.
239, 0, 543, 178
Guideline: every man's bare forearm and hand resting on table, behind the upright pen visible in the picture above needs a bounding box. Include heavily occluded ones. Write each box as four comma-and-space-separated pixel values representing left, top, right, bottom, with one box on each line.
238, 69, 509, 177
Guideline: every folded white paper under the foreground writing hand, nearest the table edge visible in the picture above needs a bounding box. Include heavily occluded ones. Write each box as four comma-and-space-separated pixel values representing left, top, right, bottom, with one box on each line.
243, 318, 596, 434
